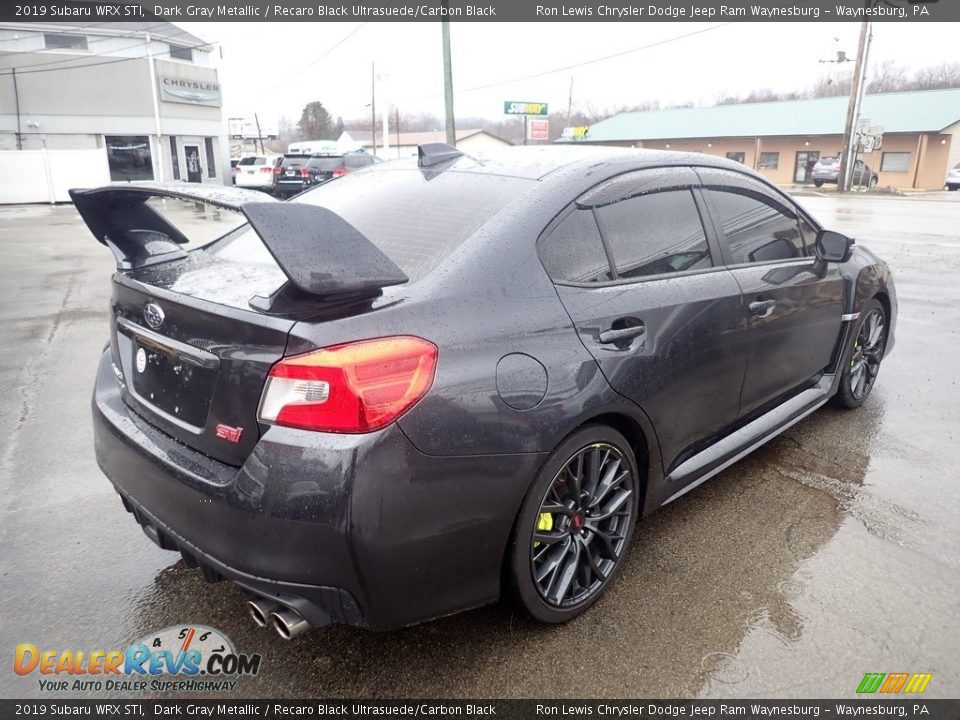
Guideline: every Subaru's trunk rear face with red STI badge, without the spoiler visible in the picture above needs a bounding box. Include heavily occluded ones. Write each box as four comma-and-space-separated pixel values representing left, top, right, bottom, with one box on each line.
111, 272, 293, 465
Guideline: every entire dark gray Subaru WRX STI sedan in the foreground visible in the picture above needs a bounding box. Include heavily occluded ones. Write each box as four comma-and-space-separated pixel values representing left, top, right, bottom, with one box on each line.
79, 146, 897, 637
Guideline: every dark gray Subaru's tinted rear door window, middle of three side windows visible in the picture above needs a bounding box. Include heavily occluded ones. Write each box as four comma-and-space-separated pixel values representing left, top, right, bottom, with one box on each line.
596, 189, 713, 279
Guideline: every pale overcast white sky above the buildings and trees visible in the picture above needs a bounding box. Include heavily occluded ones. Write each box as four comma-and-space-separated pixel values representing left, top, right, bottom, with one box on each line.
180, 22, 960, 129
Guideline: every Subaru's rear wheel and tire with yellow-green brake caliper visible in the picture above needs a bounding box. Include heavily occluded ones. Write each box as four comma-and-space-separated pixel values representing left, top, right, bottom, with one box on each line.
505, 425, 640, 623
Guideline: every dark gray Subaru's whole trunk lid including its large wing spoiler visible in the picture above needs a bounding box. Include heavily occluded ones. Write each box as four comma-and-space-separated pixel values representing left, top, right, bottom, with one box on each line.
71, 184, 406, 466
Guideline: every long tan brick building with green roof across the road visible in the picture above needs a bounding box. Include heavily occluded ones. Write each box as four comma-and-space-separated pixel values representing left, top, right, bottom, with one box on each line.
578, 89, 960, 189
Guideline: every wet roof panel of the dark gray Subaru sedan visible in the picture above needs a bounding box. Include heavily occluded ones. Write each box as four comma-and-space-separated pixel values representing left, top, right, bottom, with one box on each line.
379, 145, 744, 180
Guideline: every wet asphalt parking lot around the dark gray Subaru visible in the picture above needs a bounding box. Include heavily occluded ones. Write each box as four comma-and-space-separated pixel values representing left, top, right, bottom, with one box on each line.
0, 193, 960, 698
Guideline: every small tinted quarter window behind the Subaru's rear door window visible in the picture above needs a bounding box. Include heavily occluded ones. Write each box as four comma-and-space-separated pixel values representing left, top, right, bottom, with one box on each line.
540, 209, 611, 283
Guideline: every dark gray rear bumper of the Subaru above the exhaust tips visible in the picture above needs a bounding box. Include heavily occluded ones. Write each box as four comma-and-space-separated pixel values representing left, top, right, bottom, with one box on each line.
93, 348, 544, 629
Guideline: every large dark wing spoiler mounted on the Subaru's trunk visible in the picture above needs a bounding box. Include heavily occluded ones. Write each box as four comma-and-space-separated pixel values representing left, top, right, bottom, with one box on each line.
70, 183, 408, 296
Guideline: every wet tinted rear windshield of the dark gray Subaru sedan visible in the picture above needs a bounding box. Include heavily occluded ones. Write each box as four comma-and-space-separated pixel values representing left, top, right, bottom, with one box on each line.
207, 170, 536, 282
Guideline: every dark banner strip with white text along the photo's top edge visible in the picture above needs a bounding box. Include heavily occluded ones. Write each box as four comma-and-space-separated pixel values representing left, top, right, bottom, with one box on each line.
0, 0, 960, 23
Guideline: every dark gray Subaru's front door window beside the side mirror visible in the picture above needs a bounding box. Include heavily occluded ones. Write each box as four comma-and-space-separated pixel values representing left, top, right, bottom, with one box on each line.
704, 189, 806, 265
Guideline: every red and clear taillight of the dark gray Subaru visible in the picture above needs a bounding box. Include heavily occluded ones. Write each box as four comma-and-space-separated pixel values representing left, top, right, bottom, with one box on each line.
259, 335, 437, 433
